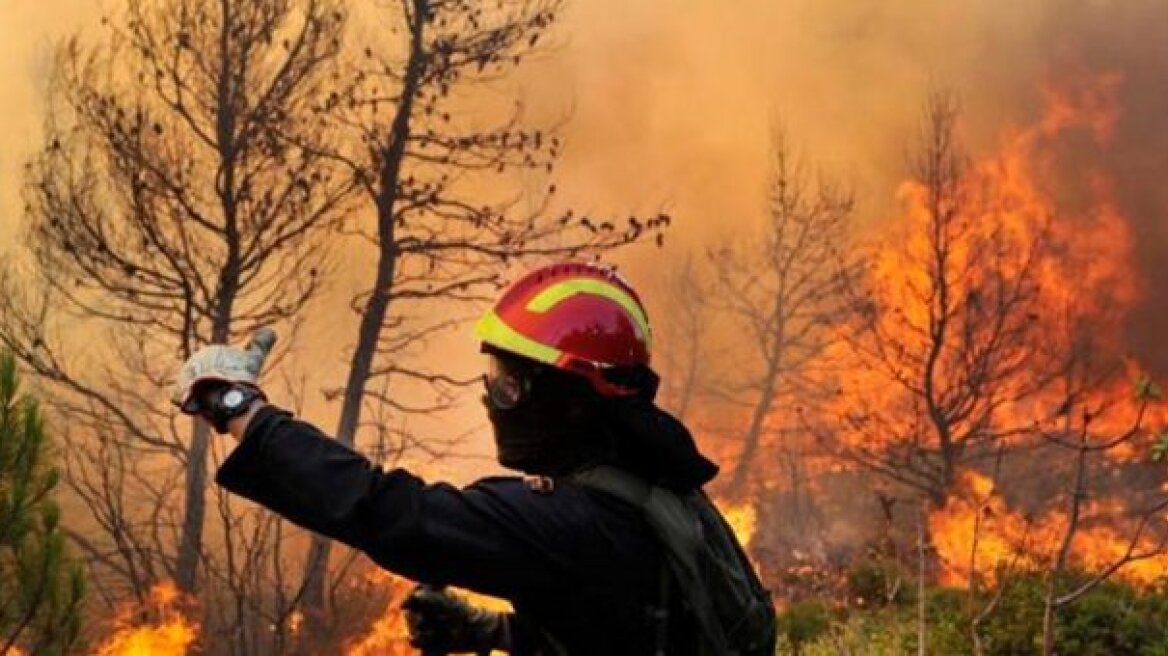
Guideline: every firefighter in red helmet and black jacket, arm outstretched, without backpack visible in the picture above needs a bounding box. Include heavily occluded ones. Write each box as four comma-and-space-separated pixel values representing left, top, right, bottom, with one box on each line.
174, 263, 717, 655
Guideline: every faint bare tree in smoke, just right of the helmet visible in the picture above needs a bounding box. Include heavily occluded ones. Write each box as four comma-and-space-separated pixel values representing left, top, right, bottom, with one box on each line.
711, 130, 855, 495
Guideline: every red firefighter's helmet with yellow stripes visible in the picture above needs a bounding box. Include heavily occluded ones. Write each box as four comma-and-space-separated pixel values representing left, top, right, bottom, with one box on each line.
474, 263, 653, 396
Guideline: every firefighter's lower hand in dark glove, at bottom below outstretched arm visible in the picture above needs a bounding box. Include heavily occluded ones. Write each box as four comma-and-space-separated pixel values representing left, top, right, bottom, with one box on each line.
402, 584, 510, 654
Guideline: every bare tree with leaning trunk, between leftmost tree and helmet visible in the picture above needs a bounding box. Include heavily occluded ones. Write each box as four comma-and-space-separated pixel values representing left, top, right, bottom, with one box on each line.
296, 0, 668, 617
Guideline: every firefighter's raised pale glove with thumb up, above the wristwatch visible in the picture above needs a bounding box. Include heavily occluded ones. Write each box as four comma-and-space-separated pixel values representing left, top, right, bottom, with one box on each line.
171, 328, 276, 414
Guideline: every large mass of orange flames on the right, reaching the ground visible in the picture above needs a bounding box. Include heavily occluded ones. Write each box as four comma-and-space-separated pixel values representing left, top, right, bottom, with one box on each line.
784, 72, 1168, 586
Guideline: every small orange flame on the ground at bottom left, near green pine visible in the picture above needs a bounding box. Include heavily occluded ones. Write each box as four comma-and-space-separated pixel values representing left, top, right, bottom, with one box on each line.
96, 581, 199, 656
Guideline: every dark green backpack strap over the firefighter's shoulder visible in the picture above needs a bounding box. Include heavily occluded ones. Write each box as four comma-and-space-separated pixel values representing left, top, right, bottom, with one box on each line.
569, 465, 731, 654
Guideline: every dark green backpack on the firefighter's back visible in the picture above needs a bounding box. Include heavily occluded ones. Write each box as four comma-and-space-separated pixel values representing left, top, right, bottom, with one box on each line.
569, 466, 778, 656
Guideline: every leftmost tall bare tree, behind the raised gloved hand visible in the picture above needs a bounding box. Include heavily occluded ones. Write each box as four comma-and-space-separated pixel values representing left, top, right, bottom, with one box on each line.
0, 0, 355, 639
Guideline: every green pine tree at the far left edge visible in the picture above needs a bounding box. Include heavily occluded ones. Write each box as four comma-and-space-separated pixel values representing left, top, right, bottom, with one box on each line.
0, 351, 85, 655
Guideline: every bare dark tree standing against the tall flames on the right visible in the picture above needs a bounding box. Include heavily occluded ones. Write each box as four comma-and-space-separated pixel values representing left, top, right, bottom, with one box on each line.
823, 91, 1050, 505
